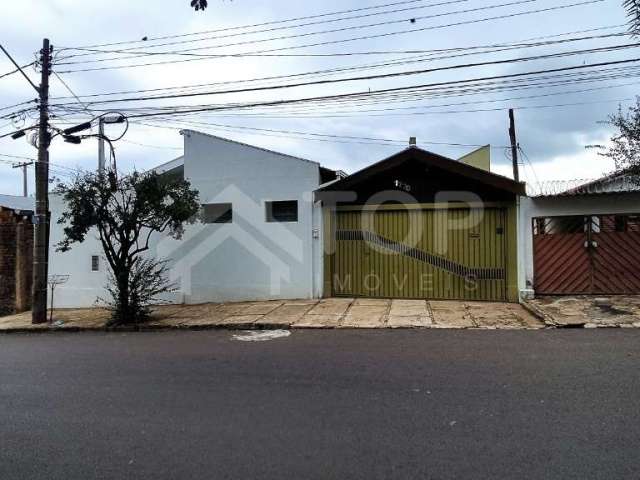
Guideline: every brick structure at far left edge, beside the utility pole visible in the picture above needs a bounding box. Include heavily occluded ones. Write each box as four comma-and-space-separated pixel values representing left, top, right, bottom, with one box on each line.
0, 195, 34, 315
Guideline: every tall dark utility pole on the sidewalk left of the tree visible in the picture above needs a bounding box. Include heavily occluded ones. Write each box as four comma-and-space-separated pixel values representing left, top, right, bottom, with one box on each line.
31, 38, 51, 323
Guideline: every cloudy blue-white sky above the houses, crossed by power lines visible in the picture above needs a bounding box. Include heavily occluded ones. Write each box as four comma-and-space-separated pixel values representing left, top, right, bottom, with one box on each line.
0, 0, 639, 195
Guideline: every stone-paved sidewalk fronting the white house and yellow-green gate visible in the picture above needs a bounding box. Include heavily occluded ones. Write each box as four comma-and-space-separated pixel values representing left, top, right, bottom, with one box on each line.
0, 298, 545, 333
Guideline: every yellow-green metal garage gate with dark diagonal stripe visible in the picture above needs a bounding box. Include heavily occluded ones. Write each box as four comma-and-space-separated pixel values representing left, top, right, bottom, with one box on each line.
332, 207, 506, 301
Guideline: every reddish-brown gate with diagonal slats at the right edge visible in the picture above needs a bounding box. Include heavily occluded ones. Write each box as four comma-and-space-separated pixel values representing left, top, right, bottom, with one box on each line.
533, 215, 640, 295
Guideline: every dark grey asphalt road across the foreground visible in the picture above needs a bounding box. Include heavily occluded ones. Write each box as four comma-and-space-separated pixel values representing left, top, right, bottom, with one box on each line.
0, 329, 640, 480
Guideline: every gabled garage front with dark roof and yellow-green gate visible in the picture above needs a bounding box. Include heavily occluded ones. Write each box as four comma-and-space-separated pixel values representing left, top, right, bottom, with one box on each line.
316, 147, 525, 302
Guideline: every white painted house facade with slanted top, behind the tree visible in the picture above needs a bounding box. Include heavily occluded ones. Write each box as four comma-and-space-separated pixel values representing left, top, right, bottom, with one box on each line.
50, 130, 323, 307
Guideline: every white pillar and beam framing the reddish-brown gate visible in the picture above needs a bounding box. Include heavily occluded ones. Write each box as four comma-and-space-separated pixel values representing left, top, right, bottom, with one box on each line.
518, 193, 640, 296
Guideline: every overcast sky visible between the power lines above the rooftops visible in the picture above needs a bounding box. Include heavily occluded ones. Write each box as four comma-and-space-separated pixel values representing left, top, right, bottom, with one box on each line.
0, 0, 638, 195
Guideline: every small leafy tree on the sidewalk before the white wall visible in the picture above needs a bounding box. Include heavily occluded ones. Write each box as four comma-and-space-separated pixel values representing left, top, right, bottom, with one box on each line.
54, 172, 199, 324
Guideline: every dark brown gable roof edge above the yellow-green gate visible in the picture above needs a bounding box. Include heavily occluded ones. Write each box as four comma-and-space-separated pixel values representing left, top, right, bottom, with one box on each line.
319, 147, 526, 196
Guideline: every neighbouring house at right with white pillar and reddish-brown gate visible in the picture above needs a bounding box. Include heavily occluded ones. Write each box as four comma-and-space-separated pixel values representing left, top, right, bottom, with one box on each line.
520, 173, 640, 297
